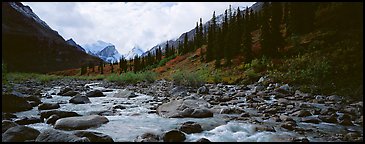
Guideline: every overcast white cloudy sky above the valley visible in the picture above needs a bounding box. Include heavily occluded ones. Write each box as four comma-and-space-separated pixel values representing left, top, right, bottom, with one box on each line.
23, 2, 254, 54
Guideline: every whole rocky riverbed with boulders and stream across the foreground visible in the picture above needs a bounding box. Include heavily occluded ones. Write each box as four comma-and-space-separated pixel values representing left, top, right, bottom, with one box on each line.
2, 78, 363, 142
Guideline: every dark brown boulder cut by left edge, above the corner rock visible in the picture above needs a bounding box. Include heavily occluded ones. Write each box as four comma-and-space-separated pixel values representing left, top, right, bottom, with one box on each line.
1, 94, 32, 112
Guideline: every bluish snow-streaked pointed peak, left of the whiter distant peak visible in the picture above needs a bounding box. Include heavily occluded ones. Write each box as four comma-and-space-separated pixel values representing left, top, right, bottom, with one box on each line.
96, 45, 122, 63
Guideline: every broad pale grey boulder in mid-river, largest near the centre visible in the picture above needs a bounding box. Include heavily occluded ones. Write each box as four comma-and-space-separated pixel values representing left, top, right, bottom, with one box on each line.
156, 99, 213, 118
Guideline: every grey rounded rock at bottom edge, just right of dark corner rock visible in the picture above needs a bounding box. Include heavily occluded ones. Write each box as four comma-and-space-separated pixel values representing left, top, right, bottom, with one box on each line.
35, 128, 90, 142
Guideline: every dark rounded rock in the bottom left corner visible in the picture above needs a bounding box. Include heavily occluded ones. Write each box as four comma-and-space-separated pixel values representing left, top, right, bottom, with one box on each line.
1, 125, 40, 142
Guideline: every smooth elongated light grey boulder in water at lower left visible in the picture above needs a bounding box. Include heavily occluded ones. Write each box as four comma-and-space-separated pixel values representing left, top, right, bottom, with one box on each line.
54, 115, 109, 130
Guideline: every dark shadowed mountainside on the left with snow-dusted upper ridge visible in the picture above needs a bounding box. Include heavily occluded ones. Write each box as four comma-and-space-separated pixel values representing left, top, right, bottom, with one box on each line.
2, 2, 101, 73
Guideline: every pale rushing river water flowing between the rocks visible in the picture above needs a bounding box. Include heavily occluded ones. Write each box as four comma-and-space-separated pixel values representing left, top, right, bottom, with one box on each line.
15, 83, 360, 142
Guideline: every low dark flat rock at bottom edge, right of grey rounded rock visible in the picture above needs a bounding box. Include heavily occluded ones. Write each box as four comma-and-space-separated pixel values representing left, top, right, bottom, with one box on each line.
73, 130, 114, 142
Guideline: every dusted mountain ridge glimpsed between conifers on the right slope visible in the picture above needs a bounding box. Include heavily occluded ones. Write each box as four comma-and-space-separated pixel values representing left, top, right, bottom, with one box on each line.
142, 2, 263, 56
